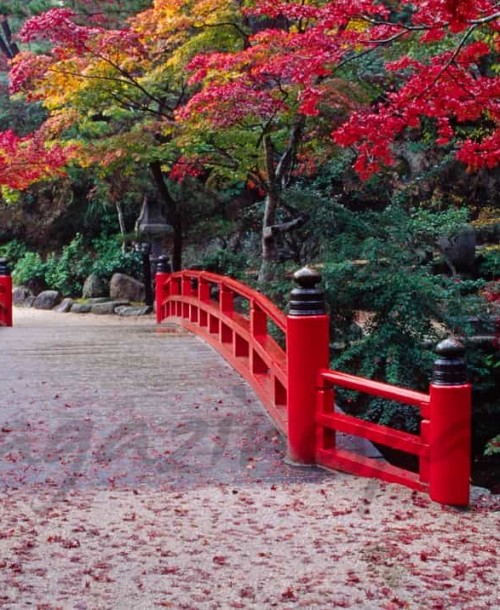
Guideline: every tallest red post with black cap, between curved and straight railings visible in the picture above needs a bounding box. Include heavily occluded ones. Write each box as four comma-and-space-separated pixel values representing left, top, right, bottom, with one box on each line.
286, 267, 330, 464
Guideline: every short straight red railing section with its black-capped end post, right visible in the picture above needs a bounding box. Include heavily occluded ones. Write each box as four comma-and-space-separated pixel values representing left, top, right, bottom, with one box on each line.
316, 339, 471, 506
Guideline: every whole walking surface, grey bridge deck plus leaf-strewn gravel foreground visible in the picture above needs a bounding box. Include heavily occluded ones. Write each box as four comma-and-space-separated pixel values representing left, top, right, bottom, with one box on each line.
0, 310, 500, 610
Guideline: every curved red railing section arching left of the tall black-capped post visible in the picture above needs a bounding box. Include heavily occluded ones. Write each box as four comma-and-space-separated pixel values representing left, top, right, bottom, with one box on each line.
156, 269, 288, 434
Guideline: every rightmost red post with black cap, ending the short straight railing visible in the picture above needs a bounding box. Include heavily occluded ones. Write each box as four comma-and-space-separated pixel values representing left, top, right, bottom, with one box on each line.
429, 338, 471, 506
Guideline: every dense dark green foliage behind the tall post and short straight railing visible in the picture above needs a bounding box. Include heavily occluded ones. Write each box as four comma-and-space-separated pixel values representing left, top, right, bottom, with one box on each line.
260, 181, 500, 432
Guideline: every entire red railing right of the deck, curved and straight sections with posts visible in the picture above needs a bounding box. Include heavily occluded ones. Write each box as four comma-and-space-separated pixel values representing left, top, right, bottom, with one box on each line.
156, 260, 471, 506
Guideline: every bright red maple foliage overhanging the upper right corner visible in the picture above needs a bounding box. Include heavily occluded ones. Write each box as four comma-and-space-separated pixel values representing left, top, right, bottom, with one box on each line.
183, 0, 500, 178
